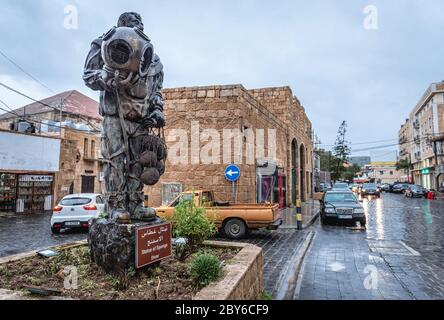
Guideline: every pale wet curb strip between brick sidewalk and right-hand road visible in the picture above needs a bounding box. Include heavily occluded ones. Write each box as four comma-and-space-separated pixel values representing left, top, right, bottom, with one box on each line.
276, 231, 315, 300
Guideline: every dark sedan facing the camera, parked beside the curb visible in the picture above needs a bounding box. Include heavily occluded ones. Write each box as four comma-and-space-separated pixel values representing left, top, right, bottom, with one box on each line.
320, 191, 367, 226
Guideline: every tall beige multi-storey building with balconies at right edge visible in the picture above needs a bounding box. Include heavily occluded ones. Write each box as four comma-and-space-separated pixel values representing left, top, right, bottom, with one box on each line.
398, 82, 444, 190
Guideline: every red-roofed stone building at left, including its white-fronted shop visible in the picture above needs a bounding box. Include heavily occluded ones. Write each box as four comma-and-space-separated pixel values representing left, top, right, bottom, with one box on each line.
0, 90, 102, 213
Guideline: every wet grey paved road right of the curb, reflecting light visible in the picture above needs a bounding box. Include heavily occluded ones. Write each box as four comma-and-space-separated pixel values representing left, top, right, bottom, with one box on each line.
293, 194, 444, 300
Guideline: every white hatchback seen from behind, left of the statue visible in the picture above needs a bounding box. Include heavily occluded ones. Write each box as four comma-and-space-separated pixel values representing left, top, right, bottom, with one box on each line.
51, 193, 105, 234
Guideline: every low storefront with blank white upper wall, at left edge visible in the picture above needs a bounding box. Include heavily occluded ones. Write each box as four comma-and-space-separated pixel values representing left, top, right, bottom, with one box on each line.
0, 130, 60, 214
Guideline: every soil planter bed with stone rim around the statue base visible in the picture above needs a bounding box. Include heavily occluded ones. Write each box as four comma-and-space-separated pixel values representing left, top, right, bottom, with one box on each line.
0, 241, 262, 300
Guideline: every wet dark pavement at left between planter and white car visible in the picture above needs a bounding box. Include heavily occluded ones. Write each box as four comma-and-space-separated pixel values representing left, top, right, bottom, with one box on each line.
0, 214, 87, 257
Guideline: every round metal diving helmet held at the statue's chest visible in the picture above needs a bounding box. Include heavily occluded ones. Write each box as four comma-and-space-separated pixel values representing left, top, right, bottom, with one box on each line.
102, 27, 154, 77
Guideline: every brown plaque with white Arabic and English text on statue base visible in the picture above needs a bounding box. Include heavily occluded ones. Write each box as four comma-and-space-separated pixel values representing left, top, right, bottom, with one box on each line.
136, 223, 172, 269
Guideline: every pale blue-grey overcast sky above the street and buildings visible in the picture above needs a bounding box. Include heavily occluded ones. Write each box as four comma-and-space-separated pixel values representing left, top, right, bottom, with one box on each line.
0, 0, 444, 160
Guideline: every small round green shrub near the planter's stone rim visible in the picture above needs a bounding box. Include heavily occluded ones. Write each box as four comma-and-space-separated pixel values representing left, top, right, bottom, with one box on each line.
190, 253, 222, 288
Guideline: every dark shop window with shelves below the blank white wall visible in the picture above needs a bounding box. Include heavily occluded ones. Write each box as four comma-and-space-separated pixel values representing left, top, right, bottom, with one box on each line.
0, 173, 54, 213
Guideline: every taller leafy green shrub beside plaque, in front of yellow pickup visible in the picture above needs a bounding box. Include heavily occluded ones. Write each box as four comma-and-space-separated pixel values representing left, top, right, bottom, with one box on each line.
172, 199, 217, 261
